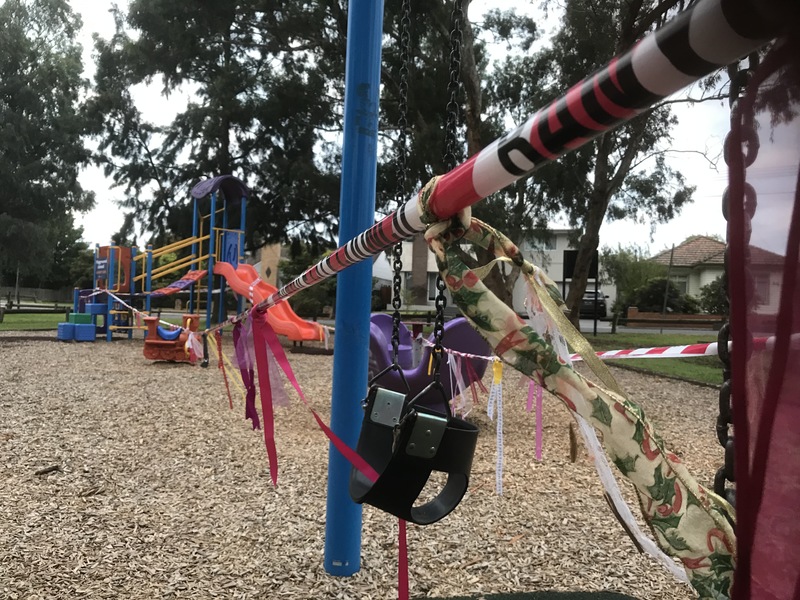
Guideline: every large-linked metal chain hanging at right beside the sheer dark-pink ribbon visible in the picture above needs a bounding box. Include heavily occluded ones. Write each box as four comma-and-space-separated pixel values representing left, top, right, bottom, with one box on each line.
714, 53, 759, 506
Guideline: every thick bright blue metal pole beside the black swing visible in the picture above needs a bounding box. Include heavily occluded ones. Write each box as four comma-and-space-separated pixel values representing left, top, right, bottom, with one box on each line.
325, 0, 383, 576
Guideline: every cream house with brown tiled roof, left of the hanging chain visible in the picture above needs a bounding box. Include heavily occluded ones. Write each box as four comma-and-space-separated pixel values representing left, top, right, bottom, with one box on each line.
650, 235, 725, 298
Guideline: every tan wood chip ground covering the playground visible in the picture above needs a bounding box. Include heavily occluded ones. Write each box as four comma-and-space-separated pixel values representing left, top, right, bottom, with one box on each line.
0, 332, 722, 600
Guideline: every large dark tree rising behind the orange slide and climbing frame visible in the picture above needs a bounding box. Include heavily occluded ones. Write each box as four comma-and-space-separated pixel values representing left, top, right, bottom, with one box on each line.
90, 0, 346, 247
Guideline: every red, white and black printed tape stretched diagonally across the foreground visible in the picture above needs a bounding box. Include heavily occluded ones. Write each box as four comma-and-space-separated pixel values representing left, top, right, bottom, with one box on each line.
258, 0, 772, 309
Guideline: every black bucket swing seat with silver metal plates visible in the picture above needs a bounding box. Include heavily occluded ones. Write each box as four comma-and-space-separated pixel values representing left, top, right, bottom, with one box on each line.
350, 385, 478, 525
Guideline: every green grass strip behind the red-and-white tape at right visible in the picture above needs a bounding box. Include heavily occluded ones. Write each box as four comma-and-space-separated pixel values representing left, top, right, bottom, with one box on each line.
586, 332, 722, 385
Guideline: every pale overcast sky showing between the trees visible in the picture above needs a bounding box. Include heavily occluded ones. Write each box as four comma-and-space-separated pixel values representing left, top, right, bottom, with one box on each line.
70, 0, 797, 253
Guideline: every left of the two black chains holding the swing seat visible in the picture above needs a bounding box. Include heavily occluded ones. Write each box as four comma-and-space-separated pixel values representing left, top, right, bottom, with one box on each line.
392, 0, 411, 366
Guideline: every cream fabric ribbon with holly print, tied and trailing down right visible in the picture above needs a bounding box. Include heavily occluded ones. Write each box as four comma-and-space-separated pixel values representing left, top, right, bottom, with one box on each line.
420, 180, 736, 599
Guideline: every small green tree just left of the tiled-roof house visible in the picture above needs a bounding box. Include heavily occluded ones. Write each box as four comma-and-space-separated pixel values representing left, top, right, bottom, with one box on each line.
600, 244, 667, 315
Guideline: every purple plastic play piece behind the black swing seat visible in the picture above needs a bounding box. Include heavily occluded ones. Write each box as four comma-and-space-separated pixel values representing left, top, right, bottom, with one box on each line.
369, 314, 492, 406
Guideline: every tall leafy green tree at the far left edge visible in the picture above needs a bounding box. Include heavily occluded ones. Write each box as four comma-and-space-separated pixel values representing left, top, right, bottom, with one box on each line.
0, 0, 94, 292
